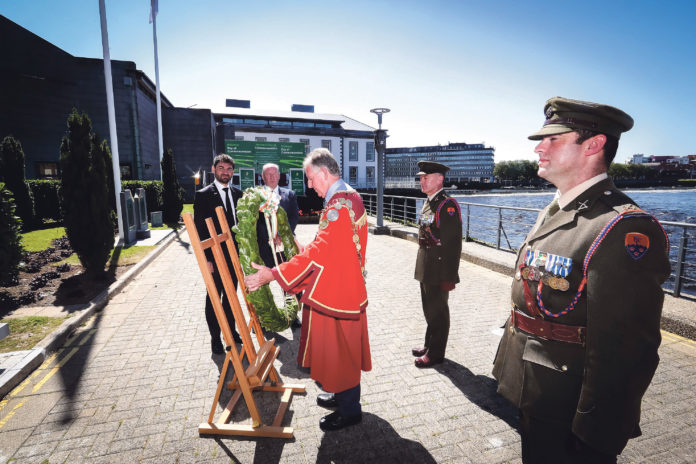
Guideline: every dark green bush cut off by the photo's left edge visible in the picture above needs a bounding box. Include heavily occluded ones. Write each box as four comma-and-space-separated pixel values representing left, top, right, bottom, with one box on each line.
0, 182, 24, 285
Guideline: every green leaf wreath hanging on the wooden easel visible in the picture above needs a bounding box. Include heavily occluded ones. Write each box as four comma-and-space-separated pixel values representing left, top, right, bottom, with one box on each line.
232, 187, 300, 332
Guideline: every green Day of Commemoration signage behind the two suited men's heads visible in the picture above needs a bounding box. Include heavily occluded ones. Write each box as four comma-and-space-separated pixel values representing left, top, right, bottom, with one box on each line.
225, 140, 305, 172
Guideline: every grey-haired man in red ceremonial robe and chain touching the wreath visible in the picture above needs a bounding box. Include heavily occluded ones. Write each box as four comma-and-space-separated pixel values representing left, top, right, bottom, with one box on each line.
244, 148, 372, 431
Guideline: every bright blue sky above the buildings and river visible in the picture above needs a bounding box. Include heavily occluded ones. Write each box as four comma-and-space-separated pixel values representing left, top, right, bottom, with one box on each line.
0, 0, 696, 162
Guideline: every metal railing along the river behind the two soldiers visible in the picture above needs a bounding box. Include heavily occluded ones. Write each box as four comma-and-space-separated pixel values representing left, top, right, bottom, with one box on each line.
361, 193, 696, 297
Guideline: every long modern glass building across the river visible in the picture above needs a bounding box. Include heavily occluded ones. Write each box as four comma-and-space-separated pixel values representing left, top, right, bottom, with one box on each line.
384, 143, 495, 188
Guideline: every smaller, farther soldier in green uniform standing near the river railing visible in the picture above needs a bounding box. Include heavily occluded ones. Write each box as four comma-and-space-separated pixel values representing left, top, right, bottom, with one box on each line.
411, 161, 462, 368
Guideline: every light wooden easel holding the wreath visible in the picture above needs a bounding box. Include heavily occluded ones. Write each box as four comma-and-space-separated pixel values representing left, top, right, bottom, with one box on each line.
182, 206, 305, 438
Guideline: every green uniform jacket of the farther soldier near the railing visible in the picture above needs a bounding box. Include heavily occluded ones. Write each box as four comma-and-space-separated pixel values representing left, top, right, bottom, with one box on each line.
415, 190, 462, 285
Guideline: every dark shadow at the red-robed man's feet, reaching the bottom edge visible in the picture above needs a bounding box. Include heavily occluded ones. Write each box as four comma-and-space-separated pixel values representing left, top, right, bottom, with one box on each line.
316, 412, 437, 464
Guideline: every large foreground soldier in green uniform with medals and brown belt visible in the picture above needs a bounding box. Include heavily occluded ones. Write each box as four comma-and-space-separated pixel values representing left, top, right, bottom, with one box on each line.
493, 97, 670, 464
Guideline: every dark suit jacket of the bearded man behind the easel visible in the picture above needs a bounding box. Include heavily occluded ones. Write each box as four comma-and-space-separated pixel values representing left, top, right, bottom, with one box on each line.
193, 183, 242, 268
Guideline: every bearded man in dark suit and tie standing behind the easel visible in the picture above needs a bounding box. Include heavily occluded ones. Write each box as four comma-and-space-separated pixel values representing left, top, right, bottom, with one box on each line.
193, 154, 242, 354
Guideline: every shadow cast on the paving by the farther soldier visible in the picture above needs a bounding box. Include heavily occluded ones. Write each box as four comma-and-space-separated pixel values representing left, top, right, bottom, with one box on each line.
435, 359, 519, 430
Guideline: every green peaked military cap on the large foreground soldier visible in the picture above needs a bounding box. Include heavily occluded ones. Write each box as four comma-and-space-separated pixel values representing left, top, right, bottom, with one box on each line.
529, 97, 633, 140
